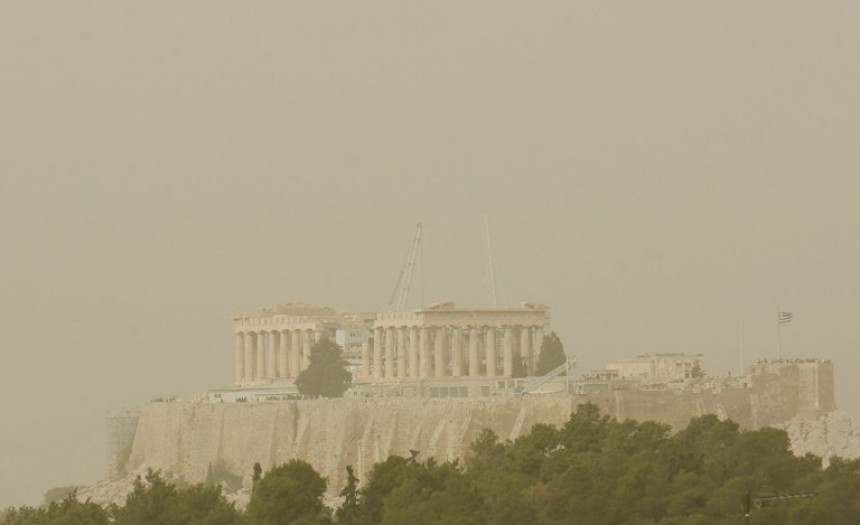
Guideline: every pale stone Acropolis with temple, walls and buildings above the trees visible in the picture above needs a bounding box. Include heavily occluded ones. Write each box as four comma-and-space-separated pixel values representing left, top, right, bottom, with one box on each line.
97, 302, 836, 504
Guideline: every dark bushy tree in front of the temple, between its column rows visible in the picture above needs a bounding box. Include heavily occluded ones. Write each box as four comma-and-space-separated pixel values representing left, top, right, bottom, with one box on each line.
296, 337, 352, 397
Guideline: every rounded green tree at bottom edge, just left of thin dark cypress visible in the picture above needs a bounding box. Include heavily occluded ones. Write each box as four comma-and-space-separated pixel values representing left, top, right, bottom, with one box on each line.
246, 459, 329, 525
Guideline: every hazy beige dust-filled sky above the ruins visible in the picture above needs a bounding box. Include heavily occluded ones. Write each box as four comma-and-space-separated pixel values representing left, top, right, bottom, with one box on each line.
0, 0, 860, 506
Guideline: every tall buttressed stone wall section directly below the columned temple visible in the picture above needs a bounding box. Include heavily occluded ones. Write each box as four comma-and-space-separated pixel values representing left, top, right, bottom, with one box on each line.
126, 398, 572, 491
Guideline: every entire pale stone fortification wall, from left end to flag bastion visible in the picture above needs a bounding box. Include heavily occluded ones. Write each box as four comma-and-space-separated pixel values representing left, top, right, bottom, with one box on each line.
126, 360, 832, 492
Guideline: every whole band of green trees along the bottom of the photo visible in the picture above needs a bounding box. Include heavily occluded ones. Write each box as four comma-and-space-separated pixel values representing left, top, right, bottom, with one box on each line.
6, 404, 860, 525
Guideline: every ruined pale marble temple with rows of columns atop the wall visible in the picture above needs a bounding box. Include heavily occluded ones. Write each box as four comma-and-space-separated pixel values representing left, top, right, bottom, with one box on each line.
233, 301, 548, 385
